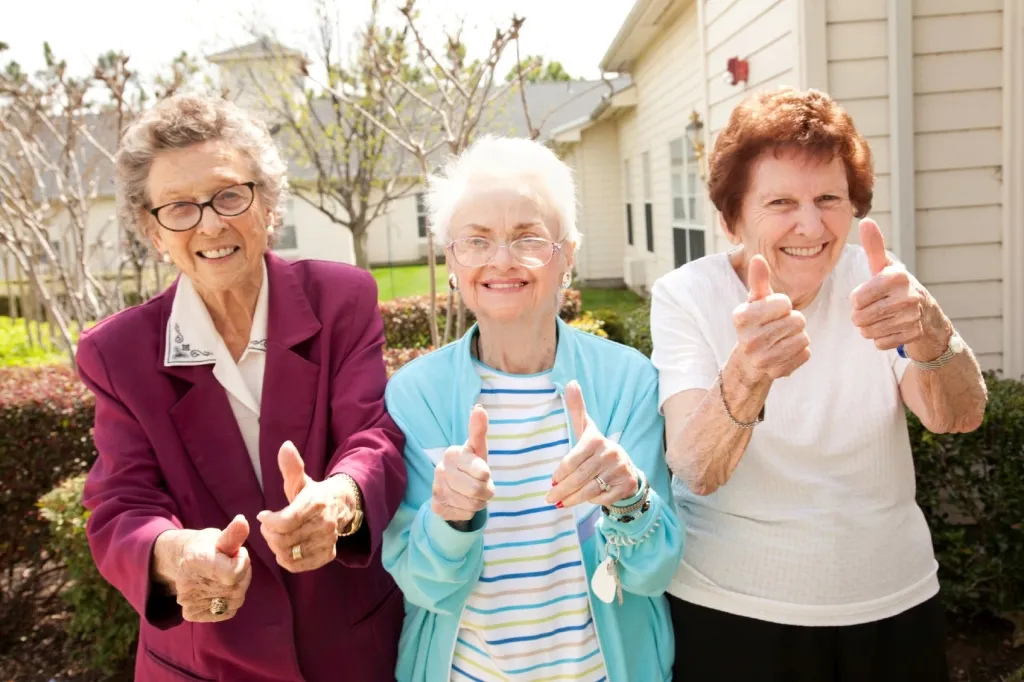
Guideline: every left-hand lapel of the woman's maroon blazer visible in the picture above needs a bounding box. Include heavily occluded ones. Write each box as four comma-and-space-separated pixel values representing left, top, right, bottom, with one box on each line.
159, 280, 282, 581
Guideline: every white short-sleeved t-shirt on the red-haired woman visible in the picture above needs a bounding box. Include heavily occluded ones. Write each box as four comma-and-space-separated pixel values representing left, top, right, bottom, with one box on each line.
651, 246, 939, 626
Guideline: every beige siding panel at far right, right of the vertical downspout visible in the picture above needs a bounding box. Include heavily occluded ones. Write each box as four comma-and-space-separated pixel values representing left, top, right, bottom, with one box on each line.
913, 0, 1002, 369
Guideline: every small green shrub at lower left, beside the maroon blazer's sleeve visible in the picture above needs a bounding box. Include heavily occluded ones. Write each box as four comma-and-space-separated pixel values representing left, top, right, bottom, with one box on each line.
39, 475, 139, 674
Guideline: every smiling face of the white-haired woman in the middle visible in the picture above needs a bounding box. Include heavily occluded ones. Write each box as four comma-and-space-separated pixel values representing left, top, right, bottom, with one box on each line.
446, 181, 572, 323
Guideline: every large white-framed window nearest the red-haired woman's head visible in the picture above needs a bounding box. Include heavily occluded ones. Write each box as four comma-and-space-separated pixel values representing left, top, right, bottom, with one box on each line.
669, 137, 705, 267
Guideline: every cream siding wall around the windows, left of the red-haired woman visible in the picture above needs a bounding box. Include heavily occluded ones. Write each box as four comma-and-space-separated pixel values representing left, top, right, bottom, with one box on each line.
616, 2, 703, 287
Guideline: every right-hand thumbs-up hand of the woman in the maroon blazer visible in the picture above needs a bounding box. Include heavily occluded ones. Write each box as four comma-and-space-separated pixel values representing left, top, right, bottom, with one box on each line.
256, 441, 358, 573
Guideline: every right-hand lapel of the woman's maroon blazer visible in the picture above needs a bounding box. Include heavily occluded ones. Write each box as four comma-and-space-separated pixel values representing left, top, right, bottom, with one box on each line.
259, 254, 321, 511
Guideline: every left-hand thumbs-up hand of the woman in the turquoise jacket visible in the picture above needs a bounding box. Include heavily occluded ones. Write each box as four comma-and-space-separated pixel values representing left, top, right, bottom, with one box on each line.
430, 406, 495, 521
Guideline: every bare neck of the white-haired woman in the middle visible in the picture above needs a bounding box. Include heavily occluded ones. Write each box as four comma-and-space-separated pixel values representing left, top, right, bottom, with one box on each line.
474, 316, 558, 374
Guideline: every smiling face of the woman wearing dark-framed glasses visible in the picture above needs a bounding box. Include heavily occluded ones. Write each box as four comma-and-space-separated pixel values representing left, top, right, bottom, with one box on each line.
146, 141, 272, 293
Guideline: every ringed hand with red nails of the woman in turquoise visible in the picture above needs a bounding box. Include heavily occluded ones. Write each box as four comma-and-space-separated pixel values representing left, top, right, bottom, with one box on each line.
545, 381, 640, 508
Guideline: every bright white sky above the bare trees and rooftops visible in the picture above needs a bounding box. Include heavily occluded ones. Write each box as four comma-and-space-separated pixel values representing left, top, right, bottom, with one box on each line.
0, 0, 633, 78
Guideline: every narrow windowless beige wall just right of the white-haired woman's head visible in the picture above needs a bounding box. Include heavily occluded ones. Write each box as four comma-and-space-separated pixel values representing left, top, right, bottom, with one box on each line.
573, 122, 626, 280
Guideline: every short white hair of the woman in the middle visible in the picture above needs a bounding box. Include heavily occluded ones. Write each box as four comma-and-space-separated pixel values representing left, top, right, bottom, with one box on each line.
425, 135, 581, 248
